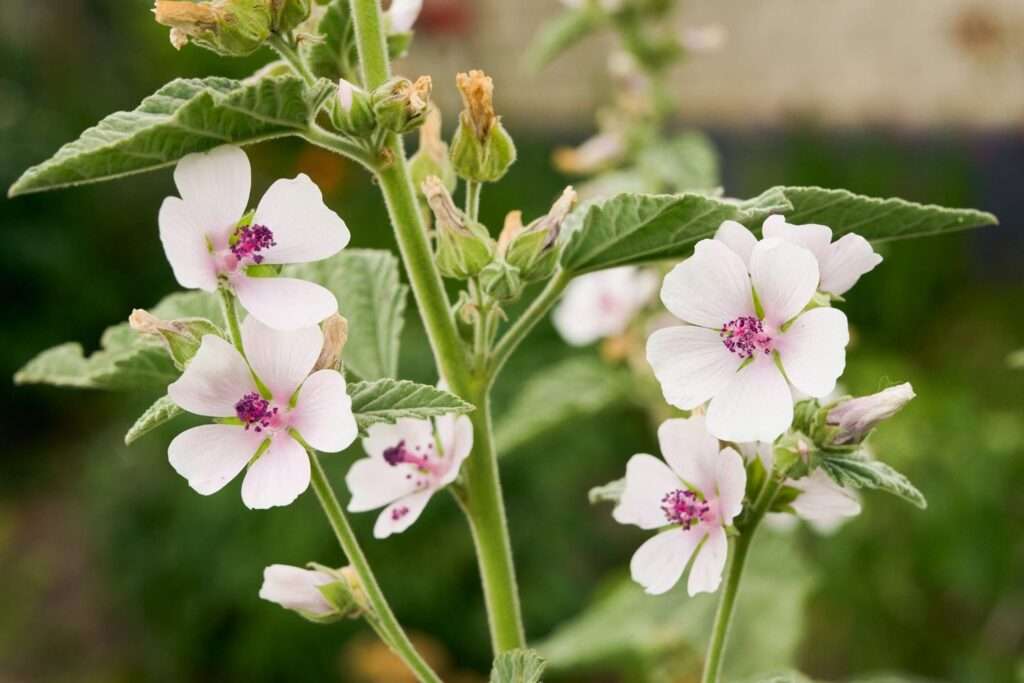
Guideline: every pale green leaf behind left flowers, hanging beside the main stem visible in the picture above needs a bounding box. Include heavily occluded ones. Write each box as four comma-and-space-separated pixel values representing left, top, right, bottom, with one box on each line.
284, 249, 409, 380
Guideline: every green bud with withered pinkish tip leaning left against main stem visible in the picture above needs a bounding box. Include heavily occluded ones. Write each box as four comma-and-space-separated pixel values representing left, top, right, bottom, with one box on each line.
423, 175, 495, 280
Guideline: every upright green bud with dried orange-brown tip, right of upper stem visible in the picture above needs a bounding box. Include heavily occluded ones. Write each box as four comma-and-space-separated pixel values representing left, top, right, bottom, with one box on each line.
452, 71, 516, 182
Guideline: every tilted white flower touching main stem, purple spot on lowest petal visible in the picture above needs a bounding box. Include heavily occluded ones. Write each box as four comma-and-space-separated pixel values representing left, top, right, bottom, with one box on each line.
345, 415, 473, 539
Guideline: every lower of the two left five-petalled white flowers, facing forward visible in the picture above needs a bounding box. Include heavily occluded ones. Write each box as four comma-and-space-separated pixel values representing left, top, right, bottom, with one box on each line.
167, 316, 358, 509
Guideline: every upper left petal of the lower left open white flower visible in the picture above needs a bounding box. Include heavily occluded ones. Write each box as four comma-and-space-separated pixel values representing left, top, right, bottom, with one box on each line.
167, 335, 256, 418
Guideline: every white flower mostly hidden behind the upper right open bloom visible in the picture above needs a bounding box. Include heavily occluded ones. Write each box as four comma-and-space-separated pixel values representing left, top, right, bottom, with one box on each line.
715, 215, 882, 296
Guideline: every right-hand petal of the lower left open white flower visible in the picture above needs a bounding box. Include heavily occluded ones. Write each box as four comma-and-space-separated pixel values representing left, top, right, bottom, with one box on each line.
291, 370, 359, 453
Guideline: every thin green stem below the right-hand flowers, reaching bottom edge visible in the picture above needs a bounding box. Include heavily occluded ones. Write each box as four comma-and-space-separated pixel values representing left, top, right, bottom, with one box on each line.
700, 473, 785, 683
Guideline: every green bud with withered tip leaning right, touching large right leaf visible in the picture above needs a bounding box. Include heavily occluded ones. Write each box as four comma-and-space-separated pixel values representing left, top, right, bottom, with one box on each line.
498, 187, 577, 283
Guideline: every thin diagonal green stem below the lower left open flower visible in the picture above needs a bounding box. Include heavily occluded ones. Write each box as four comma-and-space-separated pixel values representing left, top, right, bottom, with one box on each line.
309, 451, 441, 683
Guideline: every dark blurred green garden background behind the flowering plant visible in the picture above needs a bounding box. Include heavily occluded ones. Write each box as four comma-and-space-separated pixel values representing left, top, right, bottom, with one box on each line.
0, 0, 1024, 683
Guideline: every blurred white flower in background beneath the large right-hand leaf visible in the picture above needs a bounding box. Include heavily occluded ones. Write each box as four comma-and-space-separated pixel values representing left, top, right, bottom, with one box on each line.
553, 265, 657, 346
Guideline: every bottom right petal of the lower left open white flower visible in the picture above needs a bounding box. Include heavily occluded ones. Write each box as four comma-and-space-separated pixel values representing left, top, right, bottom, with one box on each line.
242, 434, 310, 510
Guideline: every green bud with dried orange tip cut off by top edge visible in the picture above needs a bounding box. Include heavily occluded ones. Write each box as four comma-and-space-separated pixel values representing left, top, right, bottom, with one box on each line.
154, 0, 272, 56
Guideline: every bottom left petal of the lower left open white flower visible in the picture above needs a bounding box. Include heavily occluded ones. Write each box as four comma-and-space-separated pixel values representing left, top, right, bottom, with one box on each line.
167, 425, 258, 496
